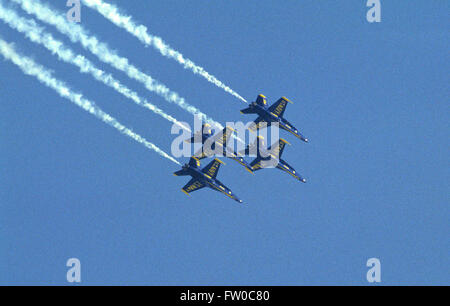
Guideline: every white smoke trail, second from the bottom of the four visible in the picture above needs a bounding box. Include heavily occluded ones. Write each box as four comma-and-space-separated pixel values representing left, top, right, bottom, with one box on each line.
0, 0, 191, 132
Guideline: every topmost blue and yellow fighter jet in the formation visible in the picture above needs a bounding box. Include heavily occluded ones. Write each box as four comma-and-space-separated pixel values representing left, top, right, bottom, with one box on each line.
241, 95, 308, 142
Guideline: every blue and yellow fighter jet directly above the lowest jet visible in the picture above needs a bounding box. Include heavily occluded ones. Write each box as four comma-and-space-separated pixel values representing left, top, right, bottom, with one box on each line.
186, 123, 253, 173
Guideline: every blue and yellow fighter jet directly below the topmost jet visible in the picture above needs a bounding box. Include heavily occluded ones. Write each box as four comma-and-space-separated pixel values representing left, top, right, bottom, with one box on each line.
240, 136, 306, 183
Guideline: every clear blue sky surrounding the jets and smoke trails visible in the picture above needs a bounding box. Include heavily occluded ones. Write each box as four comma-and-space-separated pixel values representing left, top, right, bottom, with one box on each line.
0, 0, 450, 285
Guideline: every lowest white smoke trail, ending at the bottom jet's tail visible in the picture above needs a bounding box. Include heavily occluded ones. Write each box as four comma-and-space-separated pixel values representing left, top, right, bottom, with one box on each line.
0, 38, 181, 165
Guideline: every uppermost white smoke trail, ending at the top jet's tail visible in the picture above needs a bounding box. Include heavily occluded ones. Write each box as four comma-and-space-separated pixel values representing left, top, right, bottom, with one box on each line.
83, 0, 247, 103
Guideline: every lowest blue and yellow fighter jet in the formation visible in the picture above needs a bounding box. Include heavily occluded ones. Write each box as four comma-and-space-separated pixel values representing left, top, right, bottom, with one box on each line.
174, 157, 242, 203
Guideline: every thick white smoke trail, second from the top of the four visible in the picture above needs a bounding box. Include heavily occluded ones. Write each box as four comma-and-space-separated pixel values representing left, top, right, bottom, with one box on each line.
12, 0, 223, 128
